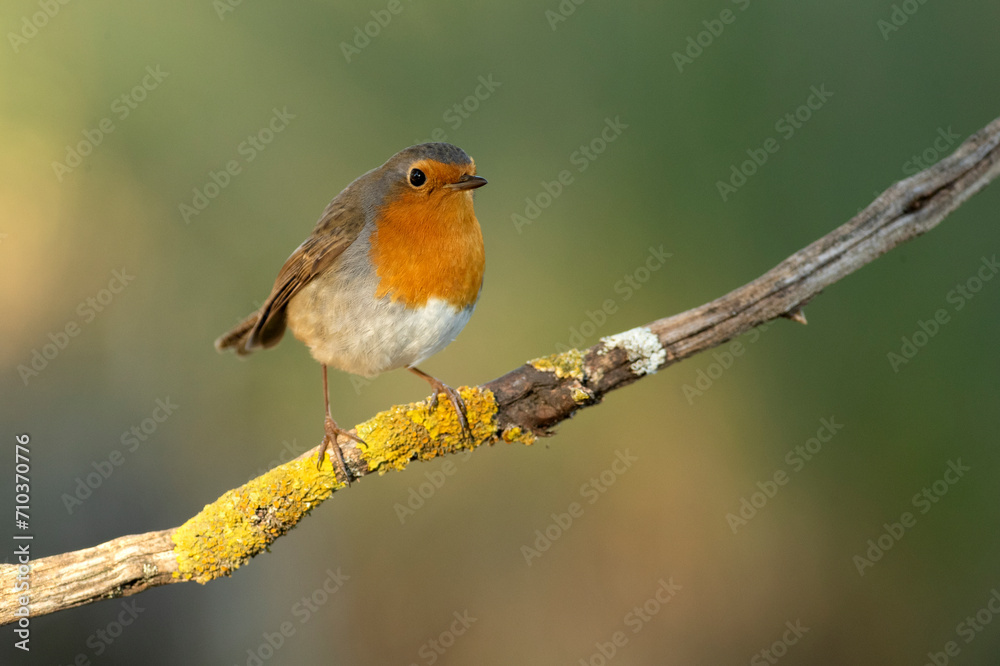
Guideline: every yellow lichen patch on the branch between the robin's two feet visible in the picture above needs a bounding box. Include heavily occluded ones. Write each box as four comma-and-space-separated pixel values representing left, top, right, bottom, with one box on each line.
358, 386, 497, 474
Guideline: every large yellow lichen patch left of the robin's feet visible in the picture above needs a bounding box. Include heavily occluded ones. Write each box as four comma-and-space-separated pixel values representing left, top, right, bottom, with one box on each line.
172, 458, 343, 583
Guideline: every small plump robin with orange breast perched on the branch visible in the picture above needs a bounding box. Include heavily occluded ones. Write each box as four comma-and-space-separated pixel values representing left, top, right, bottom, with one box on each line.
215, 143, 486, 482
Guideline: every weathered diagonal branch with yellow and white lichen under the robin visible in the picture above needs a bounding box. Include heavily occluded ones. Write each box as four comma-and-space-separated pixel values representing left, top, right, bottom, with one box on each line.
7, 113, 1000, 624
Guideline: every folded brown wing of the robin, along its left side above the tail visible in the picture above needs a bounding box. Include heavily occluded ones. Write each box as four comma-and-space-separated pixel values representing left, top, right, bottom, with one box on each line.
242, 194, 365, 352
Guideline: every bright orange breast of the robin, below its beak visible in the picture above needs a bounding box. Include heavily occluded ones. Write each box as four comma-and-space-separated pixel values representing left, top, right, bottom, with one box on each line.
370, 191, 486, 308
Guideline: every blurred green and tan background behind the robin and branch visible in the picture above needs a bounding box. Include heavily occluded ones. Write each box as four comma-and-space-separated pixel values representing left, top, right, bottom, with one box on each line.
0, 0, 1000, 666
